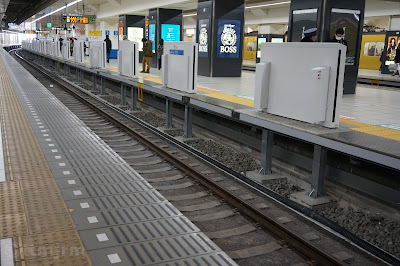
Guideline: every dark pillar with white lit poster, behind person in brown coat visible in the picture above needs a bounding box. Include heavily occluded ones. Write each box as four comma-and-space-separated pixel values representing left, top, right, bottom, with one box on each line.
118, 15, 146, 62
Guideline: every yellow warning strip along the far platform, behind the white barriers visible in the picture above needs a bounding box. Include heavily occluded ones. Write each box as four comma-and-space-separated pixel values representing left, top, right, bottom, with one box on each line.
107, 63, 400, 141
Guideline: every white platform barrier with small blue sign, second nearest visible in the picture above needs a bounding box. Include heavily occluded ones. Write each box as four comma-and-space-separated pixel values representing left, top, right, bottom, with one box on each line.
161, 42, 198, 93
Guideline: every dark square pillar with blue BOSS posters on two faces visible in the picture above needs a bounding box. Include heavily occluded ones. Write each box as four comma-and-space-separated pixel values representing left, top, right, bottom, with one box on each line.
196, 0, 245, 77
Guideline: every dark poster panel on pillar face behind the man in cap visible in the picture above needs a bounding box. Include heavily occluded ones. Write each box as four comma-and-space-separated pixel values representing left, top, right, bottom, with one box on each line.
292, 9, 318, 42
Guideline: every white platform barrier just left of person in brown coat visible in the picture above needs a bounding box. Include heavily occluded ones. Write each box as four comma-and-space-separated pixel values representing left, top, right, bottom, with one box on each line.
118, 41, 139, 78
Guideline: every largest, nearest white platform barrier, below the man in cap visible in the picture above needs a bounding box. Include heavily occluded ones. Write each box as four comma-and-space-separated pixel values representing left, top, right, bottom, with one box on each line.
254, 43, 346, 128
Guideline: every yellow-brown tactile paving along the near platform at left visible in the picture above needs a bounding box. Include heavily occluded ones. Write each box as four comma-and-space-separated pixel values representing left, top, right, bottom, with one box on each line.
0, 58, 90, 265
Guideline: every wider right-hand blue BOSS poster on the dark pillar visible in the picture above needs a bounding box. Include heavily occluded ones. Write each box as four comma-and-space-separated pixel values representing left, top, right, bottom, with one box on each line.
217, 19, 241, 58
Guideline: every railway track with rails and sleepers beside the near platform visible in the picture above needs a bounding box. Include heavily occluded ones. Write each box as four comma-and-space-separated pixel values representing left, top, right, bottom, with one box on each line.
13, 50, 388, 265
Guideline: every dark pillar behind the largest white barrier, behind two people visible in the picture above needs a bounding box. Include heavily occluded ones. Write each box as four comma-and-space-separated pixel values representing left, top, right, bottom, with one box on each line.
288, 0, 365, 94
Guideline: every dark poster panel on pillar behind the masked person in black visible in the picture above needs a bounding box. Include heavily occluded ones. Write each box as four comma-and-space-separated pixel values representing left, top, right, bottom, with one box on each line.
329, 8, 361, 65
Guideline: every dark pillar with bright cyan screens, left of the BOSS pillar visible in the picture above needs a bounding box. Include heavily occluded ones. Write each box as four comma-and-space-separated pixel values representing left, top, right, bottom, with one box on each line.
147, 8, 183, 67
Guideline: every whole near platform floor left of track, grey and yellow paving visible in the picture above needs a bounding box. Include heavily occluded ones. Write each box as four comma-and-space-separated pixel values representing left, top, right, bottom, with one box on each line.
0, 47, 236, 265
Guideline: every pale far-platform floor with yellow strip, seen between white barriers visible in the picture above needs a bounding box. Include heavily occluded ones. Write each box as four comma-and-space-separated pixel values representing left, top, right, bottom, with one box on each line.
100, 59, 400, 141
